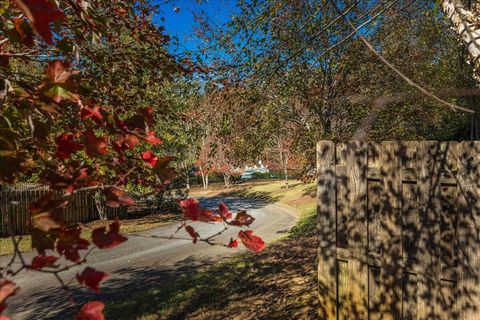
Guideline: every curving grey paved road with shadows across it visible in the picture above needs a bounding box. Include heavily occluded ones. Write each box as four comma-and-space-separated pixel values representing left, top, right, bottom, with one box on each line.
0, 197, 296, 320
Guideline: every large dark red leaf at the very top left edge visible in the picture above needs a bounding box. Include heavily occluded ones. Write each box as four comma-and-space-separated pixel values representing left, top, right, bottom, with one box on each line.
14, 0, 65, 44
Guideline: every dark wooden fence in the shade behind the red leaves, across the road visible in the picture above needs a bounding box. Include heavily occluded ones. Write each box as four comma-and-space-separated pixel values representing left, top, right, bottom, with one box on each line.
0, 186, 127, 237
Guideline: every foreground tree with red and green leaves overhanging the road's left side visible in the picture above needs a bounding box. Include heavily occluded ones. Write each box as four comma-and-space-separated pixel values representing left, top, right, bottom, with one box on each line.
0, 0, 264, 319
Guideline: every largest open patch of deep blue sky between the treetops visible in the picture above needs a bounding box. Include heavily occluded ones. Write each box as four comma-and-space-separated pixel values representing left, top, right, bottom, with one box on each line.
154, 0, 237, 53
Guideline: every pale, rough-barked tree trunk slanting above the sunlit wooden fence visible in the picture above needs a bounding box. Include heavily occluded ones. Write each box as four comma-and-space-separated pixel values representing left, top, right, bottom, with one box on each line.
442, 0, 480, 78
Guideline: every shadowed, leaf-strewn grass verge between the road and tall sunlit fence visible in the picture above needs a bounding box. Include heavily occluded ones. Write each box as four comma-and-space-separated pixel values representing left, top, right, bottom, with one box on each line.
106, 182, 316, 320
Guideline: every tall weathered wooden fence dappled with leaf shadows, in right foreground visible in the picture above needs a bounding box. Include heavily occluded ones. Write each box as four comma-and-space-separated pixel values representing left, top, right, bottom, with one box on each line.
317, 141, 480, 320
